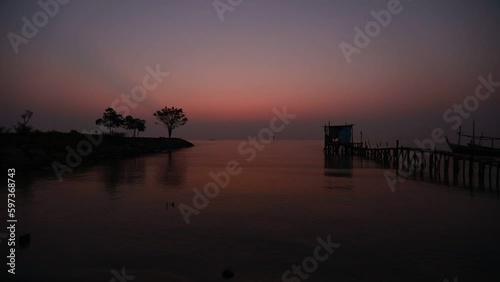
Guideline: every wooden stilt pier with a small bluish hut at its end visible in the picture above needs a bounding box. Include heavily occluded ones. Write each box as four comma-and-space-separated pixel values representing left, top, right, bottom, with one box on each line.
323, 122, 500, 193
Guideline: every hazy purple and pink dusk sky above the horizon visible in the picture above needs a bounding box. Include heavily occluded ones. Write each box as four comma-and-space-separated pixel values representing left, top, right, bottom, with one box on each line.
0, 0, 500, 145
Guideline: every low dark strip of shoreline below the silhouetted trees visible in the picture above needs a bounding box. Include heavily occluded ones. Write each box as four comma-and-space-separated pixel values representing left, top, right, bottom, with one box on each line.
0, 132, 194, 170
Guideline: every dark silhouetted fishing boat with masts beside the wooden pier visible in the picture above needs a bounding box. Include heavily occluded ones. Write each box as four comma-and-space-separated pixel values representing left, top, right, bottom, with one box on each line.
446, 122, 500, 157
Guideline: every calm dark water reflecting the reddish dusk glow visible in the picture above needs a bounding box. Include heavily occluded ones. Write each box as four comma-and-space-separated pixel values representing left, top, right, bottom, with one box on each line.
0, 141, 500, 282
